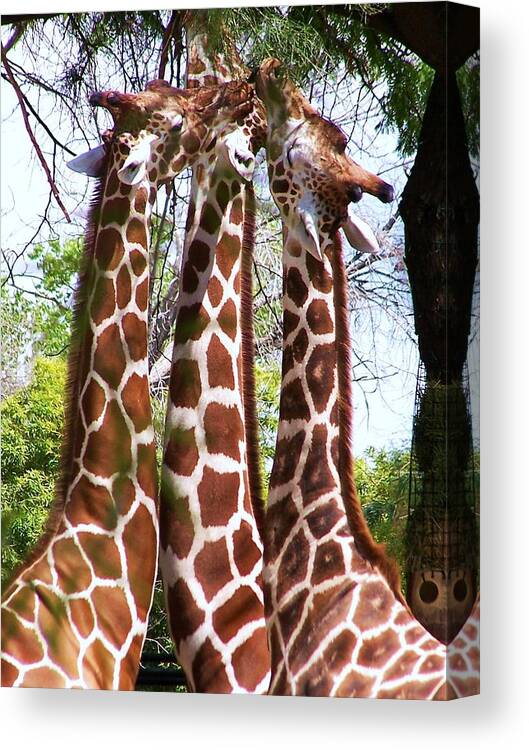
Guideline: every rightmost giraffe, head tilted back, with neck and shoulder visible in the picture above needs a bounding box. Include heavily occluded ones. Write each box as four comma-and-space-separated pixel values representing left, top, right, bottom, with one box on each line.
257, 59, 477, 699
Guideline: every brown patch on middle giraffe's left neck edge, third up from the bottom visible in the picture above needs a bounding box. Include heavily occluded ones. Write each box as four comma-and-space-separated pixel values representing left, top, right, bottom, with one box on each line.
160, 484, 195, 560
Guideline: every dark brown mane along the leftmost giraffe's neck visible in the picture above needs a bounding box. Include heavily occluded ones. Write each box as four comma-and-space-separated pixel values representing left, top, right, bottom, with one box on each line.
4, 156, 109, 590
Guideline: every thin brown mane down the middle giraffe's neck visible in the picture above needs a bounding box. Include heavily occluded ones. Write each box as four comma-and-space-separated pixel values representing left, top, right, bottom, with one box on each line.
241, 183, 265, 539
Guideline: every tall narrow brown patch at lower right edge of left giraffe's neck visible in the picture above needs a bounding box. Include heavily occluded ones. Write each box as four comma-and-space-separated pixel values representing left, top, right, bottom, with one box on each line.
123, 505, 158, 620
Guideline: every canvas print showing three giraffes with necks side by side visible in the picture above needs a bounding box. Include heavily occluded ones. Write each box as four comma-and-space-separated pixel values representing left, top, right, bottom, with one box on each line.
1, 2, 480, 700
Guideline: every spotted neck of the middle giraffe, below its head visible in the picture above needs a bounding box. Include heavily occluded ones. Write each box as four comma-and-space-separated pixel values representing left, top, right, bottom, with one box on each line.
160, 161, 269, 692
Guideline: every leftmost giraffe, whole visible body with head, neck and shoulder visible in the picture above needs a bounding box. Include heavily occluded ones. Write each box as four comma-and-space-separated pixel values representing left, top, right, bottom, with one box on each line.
2, 81, 225, 689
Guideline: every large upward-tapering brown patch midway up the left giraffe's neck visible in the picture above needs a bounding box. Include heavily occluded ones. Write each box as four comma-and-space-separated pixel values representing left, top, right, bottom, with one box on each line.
83, 399, 132, 477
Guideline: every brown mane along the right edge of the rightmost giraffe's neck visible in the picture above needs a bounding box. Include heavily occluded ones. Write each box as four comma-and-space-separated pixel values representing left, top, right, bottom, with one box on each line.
332, 232, 409, 611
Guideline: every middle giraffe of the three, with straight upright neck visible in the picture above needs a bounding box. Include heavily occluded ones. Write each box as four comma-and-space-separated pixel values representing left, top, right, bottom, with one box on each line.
160, 17, 270, 693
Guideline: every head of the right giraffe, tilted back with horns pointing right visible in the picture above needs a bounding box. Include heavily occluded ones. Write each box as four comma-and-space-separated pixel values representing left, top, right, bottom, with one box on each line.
257, 58, 393, 259
